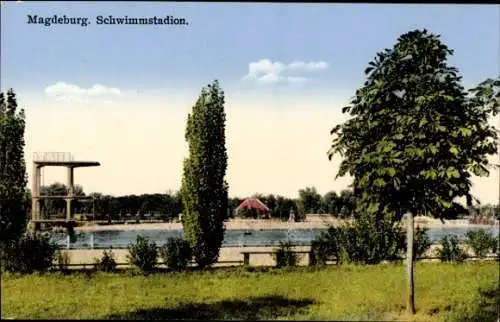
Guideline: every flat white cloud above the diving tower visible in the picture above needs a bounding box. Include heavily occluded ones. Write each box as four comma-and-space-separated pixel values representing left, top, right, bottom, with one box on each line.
45, 82, 122, 99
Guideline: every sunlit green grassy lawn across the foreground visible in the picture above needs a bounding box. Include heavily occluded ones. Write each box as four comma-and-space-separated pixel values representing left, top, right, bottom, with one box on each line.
1, 262, 500, 321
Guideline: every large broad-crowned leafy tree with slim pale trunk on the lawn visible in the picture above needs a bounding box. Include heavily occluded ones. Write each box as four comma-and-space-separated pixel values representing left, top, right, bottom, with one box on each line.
328, 30, 500, 313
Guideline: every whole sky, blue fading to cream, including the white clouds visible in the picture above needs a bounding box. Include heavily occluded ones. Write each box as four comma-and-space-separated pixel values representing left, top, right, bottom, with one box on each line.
1, 2, 500, 202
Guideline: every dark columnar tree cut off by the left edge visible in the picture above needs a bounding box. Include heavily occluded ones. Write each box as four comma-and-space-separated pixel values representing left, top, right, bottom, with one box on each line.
0, 89, 28, 246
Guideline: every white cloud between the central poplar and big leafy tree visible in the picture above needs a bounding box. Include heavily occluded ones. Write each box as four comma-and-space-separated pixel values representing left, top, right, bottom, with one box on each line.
243, 58, 329, 84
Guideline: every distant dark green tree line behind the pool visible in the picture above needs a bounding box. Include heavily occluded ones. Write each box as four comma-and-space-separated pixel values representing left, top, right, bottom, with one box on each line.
31, 182, 500, 221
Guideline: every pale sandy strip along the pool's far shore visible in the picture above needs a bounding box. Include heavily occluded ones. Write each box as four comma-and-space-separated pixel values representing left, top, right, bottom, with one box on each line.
75, 215, 499, 232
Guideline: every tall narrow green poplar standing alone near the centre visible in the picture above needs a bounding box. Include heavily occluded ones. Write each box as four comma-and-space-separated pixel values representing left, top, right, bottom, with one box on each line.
181, 80, 228, 267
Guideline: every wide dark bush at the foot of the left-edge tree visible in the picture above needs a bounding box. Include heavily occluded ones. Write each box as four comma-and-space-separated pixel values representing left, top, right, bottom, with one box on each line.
2, 233, 58, 274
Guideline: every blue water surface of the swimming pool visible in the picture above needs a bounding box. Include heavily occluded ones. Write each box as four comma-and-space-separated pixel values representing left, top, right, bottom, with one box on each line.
48, 228, 498, 249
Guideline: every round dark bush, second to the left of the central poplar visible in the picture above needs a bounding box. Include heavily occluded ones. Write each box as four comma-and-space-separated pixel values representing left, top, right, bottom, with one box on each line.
127, 235, 158, 272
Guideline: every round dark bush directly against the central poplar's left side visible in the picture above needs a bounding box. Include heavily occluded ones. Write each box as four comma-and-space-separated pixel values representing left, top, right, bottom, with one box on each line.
160, 237, 193, 271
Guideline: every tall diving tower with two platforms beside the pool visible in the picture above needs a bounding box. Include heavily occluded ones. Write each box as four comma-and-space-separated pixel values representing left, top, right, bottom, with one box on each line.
30, 152, 101, 230
